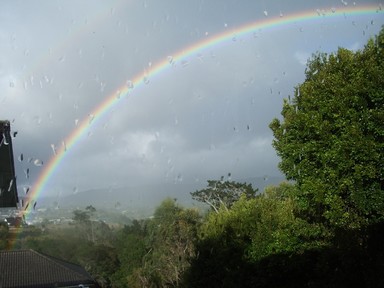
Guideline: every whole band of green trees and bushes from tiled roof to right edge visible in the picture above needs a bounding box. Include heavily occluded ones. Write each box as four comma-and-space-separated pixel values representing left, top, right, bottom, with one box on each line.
0, 25, 384, 287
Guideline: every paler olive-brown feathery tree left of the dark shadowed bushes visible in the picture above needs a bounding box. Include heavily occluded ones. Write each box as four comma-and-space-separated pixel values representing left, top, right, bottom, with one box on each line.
128, 199, 200, 287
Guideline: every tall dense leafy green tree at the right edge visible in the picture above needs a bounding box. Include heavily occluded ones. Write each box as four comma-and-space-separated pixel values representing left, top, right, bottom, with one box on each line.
270, 29, 384, 228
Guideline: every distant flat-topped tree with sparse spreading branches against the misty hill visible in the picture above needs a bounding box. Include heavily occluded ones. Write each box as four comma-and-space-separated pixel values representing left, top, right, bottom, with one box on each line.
191, 180, 258, 213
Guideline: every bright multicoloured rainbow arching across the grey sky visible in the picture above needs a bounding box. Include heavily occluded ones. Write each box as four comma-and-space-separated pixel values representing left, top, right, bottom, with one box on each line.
23, 4, 382, 222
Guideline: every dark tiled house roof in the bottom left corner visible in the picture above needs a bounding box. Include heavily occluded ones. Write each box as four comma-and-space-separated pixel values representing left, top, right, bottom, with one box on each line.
0, 250, 98, 288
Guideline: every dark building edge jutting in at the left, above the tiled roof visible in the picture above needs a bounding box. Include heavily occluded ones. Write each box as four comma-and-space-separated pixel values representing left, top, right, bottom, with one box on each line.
0, 120, 19, 208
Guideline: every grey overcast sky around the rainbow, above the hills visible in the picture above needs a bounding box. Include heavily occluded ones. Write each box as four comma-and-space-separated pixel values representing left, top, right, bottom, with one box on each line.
0, 0, 384, 202
